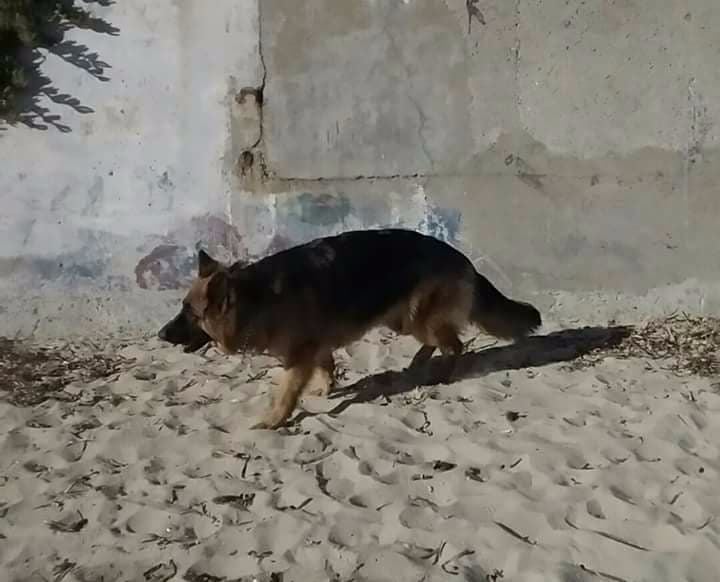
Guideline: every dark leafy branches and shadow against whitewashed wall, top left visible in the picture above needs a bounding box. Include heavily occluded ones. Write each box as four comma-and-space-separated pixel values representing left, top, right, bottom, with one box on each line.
0, 0, 119, 132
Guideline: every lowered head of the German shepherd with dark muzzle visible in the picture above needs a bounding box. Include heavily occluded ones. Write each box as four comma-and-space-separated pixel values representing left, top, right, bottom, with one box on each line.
158, 250, 236, 353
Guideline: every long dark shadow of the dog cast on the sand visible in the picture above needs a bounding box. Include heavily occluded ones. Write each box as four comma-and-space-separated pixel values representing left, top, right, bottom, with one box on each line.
292, 326, 632, 424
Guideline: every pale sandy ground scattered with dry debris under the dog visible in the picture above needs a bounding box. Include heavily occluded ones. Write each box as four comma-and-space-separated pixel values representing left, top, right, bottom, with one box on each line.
0, 324, 720, 582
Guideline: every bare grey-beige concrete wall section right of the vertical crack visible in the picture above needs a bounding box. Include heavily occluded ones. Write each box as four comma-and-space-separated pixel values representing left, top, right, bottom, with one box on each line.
248, 0, 720, 314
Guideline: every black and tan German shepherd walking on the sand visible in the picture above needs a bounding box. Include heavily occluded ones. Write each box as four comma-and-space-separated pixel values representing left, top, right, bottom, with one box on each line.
158, 228, 541, 429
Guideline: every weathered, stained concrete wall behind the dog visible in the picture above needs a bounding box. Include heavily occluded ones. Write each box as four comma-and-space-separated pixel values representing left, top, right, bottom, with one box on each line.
0, 0, 720, 335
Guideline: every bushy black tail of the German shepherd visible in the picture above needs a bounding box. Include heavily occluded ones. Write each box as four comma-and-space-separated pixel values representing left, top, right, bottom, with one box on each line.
472, 273, 542, 340
